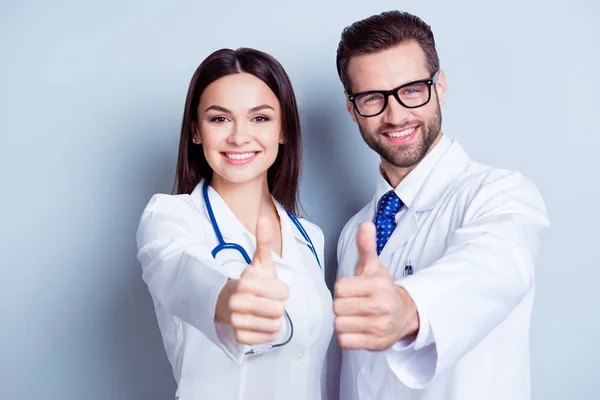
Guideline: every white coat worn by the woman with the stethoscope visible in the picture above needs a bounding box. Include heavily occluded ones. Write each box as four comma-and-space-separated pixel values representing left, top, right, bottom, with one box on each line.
137, 182, 333, 400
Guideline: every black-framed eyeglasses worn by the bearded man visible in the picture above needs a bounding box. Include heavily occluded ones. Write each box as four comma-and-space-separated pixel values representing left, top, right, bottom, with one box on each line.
348, 72, 438, 117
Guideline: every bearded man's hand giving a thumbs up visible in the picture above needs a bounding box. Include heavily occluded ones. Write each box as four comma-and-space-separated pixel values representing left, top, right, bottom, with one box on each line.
333, 222, 419, 350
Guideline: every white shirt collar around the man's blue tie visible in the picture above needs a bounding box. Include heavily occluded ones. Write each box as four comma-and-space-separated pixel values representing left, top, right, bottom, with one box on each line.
374, 134, 452, 208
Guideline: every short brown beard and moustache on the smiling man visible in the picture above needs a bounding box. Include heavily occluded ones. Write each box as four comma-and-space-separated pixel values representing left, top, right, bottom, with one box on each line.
358, 104, 442, 168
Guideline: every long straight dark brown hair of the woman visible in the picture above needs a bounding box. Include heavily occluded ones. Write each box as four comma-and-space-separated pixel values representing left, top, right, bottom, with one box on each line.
173, 48, 302, 213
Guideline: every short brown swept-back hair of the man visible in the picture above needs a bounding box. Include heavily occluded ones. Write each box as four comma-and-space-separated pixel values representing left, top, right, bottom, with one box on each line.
336, 11, 440, 93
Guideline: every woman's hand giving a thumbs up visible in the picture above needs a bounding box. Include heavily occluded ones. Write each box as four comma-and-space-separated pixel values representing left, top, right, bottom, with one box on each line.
229, 217, 289, 345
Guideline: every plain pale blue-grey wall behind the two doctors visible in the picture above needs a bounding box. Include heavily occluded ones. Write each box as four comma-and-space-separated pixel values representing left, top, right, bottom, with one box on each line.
0, 0, 600, 400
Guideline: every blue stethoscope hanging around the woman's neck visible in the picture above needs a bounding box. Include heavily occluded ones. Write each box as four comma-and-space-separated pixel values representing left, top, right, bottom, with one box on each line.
202, 181, 323, 355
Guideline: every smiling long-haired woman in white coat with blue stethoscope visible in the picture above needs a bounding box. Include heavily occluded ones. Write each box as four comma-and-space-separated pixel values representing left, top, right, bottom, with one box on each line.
137, 49, 333, 400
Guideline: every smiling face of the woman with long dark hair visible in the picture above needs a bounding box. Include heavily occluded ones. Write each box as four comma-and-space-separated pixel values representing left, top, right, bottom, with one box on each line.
194, 72, 283, 188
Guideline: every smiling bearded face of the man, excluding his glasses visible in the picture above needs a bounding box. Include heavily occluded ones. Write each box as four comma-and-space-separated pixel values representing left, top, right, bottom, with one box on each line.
346, 41, 446, 168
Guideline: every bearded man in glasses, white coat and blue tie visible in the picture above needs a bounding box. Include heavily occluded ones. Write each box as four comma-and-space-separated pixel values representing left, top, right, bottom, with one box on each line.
333, 11, 549, 400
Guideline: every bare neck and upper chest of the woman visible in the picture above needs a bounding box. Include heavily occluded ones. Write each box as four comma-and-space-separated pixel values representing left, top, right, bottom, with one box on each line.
210, 174, 279, 235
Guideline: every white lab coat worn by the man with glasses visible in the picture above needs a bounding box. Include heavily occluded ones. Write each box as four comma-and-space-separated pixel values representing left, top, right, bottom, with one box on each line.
338, 137, 549, 400
